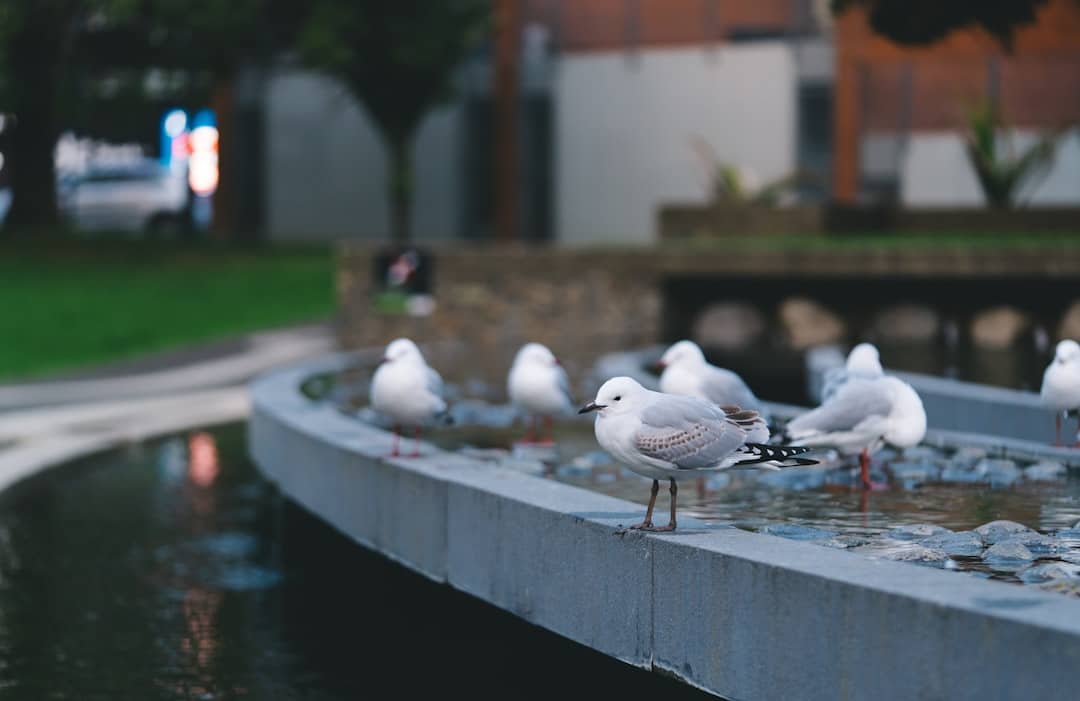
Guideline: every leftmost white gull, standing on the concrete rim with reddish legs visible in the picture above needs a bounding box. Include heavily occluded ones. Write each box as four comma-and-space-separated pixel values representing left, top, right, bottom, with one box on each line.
370, 338, 446, 458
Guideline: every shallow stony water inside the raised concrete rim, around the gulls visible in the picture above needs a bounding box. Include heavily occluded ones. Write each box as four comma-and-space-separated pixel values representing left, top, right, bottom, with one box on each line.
307, 370, 1080, 597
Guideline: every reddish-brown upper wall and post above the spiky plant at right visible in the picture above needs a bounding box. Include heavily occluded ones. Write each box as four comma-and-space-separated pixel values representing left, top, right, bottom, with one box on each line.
833, 0, 1080, 203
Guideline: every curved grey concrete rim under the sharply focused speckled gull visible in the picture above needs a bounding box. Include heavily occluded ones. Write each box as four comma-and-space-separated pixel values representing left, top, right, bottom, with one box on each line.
248, 356, 1080, 700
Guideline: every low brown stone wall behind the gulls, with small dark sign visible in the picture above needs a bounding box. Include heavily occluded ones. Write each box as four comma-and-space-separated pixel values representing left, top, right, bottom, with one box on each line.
338, 246, 660, 387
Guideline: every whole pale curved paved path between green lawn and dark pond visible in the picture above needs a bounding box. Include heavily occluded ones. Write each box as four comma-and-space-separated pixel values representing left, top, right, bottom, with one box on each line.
0, 326, 335, 491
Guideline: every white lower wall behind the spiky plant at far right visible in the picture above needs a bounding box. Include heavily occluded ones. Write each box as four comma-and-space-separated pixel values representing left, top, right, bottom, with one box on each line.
900, 131, 1080, 207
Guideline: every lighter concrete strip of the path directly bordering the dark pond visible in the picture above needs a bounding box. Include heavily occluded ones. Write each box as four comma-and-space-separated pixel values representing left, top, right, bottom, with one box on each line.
0, 387, 251, 491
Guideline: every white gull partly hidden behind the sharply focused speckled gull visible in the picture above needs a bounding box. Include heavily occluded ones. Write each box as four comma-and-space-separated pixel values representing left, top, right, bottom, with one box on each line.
657, 340, 769, 422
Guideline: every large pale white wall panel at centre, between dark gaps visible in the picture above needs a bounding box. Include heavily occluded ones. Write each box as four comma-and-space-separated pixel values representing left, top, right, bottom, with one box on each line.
554, 41, 797, 244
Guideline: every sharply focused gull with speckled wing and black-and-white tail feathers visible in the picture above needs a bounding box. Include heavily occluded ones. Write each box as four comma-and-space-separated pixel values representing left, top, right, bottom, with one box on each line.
578, 377, 816, 530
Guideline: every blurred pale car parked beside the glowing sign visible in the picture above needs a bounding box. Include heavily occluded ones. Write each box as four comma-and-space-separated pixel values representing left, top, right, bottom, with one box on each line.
57, 161, 189, 237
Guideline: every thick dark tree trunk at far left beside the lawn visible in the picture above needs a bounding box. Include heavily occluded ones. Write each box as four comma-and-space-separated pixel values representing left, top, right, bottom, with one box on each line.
4, 11, 63, 231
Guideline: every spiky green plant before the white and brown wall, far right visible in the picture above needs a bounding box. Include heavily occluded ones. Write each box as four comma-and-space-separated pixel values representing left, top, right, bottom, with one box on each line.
964, 103, 1067, 210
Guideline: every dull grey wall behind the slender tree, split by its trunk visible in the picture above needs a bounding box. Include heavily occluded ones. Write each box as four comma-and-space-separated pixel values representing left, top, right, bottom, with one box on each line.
265, 70, 462, 241
